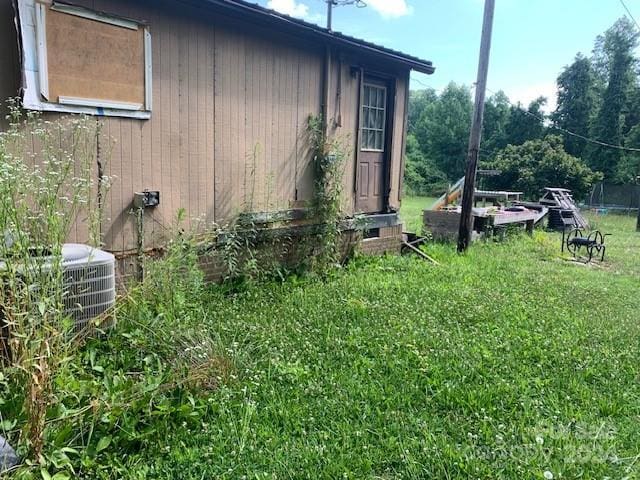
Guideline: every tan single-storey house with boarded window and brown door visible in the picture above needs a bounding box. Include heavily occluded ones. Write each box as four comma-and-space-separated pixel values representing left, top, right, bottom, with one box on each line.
0, 0, 434, 278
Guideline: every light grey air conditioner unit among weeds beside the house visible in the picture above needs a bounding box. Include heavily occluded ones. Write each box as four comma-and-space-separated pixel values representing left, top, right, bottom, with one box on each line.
62, 243, 116, 330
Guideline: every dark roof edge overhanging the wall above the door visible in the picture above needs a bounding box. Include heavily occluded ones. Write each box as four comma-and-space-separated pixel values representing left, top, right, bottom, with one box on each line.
195, 0, 435, 74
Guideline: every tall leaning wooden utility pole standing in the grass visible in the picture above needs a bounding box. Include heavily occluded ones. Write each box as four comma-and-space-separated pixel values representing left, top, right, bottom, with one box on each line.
458, 0, 495, 253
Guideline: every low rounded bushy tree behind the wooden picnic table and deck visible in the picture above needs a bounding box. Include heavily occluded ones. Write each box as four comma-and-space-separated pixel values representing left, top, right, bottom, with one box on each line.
491, 135, 602, 199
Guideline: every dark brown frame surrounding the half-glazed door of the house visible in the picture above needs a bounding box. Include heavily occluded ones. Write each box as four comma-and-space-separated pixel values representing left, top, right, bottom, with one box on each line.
353, 67, 397, 213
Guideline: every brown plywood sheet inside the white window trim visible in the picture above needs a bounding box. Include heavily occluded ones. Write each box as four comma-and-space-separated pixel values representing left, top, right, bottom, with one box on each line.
46, 9, 145, 108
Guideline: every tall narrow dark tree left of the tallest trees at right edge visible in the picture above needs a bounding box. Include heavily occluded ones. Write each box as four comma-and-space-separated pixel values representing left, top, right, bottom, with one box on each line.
551, 54, 597, 158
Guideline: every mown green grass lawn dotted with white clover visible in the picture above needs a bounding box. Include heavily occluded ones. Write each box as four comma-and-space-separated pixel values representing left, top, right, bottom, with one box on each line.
6, 208, 640, 479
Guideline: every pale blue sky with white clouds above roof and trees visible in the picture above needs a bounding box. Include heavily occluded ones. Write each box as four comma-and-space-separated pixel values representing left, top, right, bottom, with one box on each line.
254, 0, 640, 111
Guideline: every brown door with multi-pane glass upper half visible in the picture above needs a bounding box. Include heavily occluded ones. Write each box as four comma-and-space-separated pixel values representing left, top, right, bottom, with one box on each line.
356, 79, 389, 213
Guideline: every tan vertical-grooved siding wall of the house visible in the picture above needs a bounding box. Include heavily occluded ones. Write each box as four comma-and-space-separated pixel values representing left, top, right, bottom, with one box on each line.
0, 0, 408, 253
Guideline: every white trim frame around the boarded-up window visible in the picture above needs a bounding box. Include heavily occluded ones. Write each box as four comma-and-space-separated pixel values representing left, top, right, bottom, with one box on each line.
18, 0, 153, 120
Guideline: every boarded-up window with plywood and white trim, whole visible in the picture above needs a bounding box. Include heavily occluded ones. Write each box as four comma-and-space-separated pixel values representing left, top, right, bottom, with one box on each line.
20, 1, 152, 118
